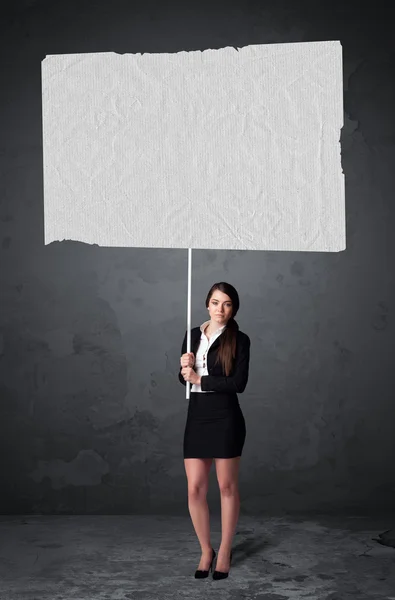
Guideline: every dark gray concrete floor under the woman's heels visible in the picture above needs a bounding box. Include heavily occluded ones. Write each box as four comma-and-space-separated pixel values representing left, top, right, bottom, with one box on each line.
0, 515, 395, 600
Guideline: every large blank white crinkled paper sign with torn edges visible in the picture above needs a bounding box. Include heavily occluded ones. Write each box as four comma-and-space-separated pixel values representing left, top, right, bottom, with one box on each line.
42, 41, 346, 252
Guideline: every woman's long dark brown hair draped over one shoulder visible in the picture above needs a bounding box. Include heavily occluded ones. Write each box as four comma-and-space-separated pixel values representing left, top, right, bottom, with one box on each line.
206, 281, 240, 377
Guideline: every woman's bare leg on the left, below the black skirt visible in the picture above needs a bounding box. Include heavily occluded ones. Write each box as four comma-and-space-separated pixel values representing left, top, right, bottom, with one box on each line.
184, 458, 212, 570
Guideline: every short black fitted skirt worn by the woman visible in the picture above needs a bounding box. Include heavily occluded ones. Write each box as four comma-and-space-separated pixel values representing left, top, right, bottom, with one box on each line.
184, 392, 246, 458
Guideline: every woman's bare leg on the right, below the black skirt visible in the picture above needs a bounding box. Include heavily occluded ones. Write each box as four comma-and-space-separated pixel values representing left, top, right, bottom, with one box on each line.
215, 456, 240, 572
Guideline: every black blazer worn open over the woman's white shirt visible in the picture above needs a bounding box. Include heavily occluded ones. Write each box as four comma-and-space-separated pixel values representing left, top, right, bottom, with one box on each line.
178, 327, 251, 394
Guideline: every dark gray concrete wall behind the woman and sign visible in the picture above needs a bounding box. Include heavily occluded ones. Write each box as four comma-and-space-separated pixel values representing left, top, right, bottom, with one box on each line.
0, 0, 395, 513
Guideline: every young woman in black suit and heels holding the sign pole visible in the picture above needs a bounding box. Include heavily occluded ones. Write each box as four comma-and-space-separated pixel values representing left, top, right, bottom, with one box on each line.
179, 282, 250, 579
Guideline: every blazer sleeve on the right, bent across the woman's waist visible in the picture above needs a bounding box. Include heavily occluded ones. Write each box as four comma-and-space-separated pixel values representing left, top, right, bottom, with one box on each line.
201, 334, 251, 394
